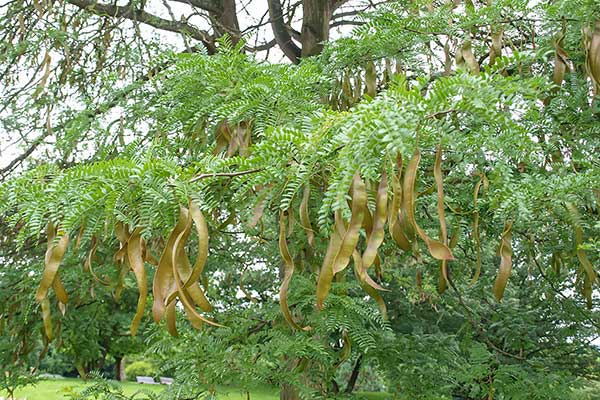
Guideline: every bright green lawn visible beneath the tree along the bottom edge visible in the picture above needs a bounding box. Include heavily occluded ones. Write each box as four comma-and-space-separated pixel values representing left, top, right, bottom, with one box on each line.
0, 378, 389, 400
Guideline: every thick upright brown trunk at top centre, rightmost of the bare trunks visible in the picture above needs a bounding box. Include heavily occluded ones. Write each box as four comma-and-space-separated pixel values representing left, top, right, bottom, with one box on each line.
302, 0, 332, 57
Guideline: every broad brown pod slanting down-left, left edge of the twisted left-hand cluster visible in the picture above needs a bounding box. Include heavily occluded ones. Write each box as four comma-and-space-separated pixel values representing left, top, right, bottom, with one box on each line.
152, 207, 188, 323
